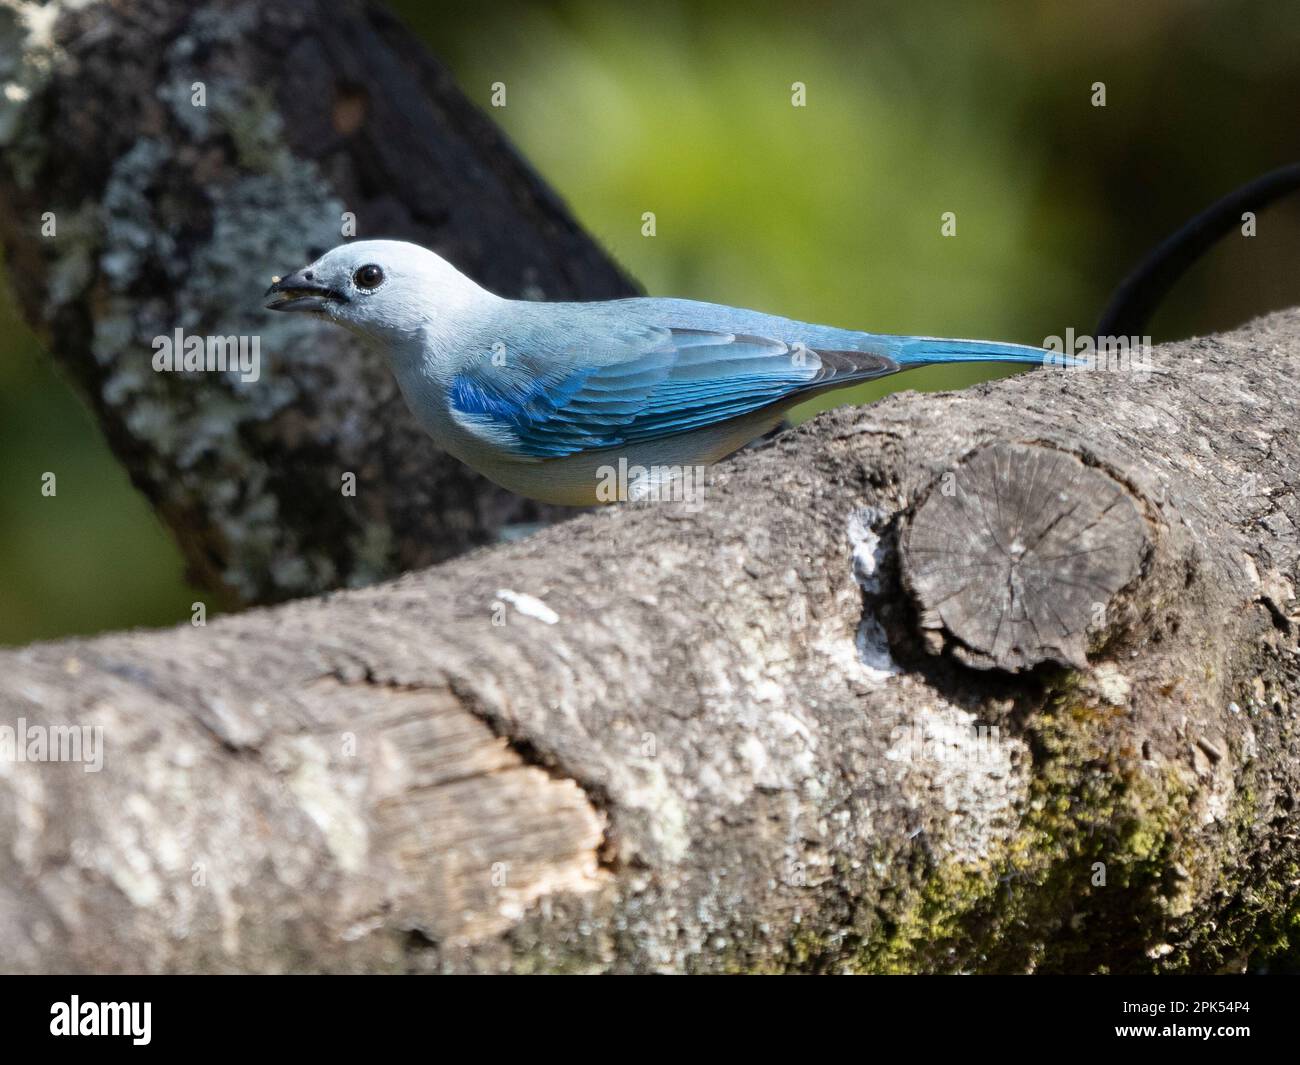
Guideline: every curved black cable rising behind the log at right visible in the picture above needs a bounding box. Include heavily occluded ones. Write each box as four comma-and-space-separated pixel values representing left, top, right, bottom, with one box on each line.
1095, 163, 1300, 337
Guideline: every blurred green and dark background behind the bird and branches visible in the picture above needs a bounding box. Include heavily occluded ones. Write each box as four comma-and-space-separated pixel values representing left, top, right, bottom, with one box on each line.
0, 0, 1300, 644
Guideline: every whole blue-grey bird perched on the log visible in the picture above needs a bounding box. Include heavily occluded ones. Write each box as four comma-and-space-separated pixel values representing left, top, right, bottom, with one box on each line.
267, 241, 1052, 506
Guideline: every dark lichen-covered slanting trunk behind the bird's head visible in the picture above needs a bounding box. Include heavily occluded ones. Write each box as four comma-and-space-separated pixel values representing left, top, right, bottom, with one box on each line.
0, 0, 633, 606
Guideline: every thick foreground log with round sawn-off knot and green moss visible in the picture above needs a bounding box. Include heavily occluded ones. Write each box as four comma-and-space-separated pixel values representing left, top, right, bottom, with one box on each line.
0, 312, 1300, 973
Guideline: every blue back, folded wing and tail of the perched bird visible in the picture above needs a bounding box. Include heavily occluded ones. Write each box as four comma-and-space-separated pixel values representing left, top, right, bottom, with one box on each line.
449, 299, 1044, 459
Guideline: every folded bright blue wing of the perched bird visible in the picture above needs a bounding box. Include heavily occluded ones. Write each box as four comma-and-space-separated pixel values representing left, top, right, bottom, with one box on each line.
450, 328, 898, 459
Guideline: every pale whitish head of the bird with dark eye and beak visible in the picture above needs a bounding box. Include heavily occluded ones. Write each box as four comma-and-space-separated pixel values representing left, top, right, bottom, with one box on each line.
267, 241, 490, 342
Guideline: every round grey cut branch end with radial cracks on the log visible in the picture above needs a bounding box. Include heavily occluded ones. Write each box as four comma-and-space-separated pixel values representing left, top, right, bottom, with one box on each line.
902, 443, 1148, 672
